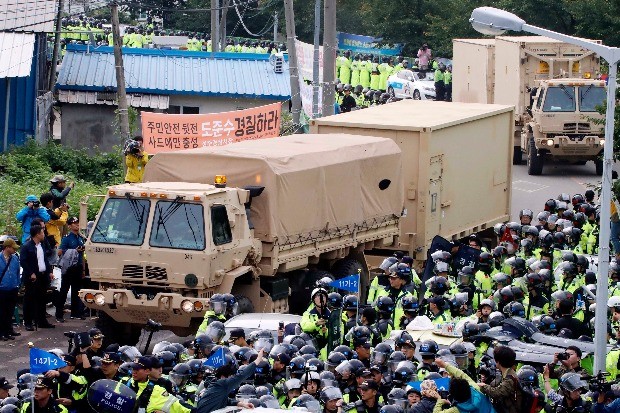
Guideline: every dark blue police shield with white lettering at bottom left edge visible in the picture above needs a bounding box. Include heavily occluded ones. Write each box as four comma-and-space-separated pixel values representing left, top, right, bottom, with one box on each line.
88, 379, 137, 413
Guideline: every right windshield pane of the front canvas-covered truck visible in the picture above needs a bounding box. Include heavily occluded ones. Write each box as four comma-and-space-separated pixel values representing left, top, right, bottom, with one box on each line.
150, 200, 205, 250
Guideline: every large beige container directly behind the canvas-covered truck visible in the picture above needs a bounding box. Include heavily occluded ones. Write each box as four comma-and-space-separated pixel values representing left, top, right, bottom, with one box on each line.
310, 100, 514, 259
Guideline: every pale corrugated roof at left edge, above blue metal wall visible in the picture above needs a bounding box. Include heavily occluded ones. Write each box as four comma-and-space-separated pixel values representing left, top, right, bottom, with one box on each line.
0, 31, 35, 78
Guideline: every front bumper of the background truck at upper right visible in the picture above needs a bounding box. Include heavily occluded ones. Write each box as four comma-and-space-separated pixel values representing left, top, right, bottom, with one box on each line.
536, 135, 605, 159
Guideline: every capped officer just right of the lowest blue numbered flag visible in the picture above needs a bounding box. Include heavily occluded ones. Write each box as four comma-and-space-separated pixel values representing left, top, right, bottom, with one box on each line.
44, 354, 88, 411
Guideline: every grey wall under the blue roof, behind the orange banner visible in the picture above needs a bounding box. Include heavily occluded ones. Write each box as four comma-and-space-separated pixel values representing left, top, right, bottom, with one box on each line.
61, 96, 288, 153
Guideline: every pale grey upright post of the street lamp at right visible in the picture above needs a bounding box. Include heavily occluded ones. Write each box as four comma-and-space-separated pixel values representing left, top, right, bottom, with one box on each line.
594, 58, 620, 374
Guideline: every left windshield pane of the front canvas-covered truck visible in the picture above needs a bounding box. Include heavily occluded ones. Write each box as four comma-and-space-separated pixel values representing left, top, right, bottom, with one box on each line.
90, 198, 151, 245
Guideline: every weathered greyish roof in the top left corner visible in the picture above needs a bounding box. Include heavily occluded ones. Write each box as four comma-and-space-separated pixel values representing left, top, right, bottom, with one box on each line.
0, 0, 58, 33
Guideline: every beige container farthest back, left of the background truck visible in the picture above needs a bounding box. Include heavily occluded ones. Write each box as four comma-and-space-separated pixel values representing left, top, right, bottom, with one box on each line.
452, 39, 495, 103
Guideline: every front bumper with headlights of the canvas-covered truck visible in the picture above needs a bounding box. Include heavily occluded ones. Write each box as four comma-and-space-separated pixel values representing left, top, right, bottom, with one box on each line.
79, 288, 209, 327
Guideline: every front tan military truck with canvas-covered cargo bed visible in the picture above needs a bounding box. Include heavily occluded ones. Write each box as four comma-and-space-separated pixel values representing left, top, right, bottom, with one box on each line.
80, 135, 403, 342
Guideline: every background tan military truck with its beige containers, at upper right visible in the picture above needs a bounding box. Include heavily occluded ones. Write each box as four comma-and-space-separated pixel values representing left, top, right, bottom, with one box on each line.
452, 36, 606, 175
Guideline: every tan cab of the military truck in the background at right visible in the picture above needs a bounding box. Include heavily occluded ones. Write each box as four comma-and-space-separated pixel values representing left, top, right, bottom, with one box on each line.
521, 79, 606, 175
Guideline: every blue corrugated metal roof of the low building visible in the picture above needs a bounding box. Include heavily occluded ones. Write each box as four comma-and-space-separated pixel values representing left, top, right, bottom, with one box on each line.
57, 44, 291, 100
